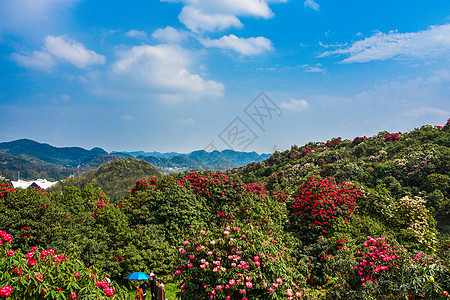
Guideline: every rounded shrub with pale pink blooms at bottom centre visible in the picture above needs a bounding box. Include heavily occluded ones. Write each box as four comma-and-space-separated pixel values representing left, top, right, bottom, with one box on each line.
174, 223, 310, 300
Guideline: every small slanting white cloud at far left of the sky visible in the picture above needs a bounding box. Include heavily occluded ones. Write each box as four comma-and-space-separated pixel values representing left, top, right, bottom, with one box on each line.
45, 35, 106, 68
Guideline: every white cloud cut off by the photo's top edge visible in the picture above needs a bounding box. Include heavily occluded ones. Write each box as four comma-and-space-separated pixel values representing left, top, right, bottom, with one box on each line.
162, 0, 285, 32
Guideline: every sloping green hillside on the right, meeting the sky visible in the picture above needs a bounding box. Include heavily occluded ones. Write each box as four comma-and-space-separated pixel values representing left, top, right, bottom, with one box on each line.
231, 125, 450, 231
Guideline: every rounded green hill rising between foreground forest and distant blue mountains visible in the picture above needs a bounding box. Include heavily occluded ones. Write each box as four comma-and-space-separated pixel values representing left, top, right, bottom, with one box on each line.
50, 158, 162, 199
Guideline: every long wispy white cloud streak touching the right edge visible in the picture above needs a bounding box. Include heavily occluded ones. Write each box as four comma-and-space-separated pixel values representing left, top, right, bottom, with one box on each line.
320, 24, 450, 63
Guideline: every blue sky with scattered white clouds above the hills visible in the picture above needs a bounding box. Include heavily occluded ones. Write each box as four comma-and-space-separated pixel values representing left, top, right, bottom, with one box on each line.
0, 0, 450, 153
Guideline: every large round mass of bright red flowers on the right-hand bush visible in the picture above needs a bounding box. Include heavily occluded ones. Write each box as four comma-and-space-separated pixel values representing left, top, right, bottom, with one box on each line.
292, 177, 362, 233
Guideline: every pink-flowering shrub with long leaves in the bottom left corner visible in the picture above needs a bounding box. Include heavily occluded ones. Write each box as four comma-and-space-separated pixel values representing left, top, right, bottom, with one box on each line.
0, 231, 124, 299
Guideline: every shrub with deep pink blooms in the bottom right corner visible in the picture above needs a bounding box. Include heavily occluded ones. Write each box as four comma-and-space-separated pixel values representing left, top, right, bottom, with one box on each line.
325, 237, 450, 299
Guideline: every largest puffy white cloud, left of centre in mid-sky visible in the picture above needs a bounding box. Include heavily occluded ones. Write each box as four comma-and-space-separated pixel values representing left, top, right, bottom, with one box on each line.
111, 44, 225, 102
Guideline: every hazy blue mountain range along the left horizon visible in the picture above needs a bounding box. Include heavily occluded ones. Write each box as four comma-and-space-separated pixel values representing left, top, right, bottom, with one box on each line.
0, 139, 270, 180
